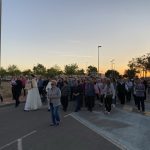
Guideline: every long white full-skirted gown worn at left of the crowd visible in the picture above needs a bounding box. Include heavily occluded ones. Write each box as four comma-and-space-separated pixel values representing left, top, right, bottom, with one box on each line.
24, 79, 42, 111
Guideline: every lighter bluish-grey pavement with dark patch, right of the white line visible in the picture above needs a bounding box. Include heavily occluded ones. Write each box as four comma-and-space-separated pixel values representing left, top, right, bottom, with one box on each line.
71, 108, 150, 150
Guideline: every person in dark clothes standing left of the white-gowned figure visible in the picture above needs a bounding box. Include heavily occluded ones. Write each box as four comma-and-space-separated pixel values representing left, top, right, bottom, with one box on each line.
14, 77, 22, 107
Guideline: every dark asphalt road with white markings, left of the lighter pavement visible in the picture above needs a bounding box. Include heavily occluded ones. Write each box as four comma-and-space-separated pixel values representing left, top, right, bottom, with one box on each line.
0, 104, 120, 150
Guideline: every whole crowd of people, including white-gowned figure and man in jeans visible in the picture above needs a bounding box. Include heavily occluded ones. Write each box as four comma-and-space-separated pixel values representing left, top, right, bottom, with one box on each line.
7, 75, 147, 125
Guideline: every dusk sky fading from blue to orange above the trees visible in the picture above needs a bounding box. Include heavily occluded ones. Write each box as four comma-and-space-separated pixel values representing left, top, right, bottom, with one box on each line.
1, 0, 150, 73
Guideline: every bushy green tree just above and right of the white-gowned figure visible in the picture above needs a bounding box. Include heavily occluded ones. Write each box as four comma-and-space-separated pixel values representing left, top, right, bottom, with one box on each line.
33, 64, 46, 75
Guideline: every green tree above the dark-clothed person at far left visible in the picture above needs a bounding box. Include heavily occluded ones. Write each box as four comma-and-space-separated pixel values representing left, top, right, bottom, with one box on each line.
7, 65, 21, 76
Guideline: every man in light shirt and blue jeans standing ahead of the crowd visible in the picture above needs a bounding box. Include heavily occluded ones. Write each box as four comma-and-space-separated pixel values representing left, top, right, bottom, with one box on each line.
47, 80, 61, 126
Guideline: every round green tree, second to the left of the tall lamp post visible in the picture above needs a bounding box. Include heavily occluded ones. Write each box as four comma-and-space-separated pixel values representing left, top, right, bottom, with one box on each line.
64, 64, 78, 75
